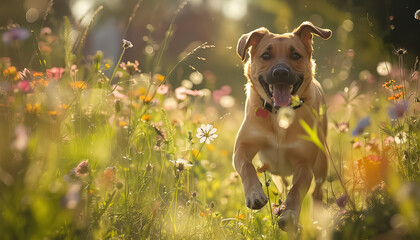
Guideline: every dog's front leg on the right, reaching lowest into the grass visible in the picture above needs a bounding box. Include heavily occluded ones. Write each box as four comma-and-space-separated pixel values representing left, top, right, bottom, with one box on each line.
278, 166, 313, 231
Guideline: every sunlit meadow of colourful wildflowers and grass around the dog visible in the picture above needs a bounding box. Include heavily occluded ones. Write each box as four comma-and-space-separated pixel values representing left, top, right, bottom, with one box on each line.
0, 1, 420, 239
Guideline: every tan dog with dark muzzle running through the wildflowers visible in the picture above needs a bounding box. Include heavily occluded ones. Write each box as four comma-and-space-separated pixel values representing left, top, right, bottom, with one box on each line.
233, 22, 331, 230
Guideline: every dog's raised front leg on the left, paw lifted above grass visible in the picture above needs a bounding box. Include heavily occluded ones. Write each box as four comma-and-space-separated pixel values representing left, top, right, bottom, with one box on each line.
233, 143, 268, 209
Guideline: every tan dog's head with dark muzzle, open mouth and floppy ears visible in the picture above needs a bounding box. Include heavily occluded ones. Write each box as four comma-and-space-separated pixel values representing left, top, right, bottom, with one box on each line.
237, 22, 331, 106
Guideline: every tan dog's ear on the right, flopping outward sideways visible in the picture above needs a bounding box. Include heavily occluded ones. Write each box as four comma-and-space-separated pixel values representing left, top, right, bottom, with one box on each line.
293, 21, 332, 54
